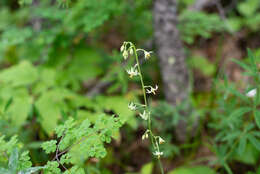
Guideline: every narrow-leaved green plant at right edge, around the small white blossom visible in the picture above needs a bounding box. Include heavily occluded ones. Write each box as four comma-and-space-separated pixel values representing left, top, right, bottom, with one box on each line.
210, 50, 260, 173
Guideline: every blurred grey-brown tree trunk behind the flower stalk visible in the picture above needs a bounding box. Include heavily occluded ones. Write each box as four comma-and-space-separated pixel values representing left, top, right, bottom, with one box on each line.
153, 0, 190, 142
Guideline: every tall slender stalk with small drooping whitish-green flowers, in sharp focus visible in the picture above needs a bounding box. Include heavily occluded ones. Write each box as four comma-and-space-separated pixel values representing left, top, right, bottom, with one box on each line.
120, 42, 165, 174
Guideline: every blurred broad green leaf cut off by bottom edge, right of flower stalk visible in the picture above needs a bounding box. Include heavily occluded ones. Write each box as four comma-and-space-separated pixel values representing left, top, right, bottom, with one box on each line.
168, 166, 216, 174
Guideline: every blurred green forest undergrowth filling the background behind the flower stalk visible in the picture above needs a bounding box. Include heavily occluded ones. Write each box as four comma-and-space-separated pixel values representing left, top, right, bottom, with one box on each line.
0, 0, 260, 174
